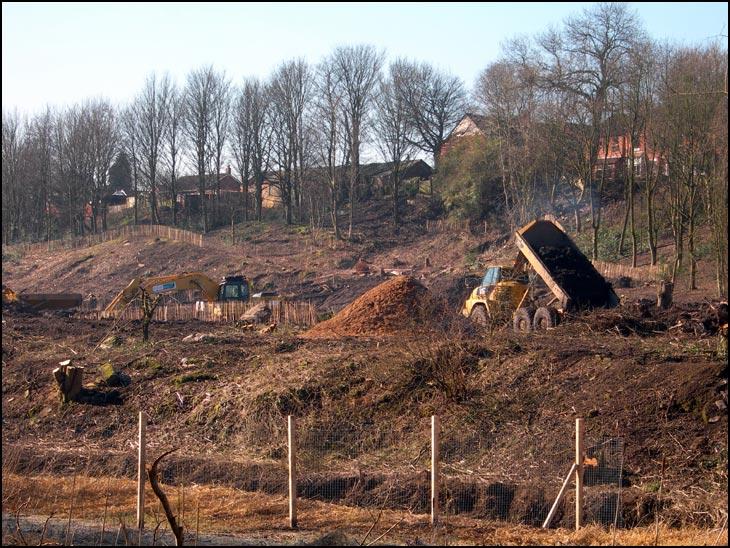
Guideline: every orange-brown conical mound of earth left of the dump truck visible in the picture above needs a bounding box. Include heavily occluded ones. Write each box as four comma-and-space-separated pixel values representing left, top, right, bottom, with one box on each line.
303, 276, 430, 338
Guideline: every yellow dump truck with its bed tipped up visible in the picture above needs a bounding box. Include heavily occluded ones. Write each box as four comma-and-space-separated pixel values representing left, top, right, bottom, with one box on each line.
461, 220, 619, 332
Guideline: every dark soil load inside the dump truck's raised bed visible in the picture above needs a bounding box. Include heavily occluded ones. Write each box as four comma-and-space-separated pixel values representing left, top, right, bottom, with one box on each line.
538, 246, 611, 308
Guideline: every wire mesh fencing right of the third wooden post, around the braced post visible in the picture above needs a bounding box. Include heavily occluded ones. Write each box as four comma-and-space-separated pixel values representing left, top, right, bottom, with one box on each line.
441, 430, 623, 528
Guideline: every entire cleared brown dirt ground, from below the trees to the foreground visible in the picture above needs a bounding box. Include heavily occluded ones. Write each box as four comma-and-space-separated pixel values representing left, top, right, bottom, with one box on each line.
2, 200, 727, 544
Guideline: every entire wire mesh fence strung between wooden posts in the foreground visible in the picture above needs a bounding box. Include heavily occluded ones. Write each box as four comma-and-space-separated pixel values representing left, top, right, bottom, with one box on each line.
2, 416, 624, 544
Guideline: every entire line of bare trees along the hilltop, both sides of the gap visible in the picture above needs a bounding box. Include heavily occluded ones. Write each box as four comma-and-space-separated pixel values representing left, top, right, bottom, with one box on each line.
2, 3, 728, 294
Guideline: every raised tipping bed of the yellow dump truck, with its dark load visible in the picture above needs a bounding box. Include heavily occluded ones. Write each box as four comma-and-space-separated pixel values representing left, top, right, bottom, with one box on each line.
515, 221, 619, 309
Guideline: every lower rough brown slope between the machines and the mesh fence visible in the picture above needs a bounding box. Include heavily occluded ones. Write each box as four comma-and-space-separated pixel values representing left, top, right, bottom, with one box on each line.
2, 304, 727, 525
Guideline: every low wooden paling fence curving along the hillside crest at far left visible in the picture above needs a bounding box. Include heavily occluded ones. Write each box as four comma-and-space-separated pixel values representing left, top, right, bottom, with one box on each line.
4, 225, 204, 253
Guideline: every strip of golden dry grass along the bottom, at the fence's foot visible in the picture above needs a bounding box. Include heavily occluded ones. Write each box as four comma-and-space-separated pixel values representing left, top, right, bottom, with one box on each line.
2, 474, 728, 546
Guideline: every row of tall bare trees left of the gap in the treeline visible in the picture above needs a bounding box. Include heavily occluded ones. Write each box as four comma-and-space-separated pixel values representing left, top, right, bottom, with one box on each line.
2, 45, 466, 242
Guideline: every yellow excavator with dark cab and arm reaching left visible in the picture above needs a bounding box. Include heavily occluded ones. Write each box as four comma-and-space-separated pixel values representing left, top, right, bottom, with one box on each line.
102, 272, 251, 317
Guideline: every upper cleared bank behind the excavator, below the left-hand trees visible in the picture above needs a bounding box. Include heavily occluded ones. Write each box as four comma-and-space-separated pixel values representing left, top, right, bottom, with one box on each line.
3, 199, 490, 310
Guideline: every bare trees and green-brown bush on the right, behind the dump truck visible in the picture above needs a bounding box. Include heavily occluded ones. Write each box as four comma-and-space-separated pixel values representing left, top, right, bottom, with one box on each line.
435, 3, 728, 295
